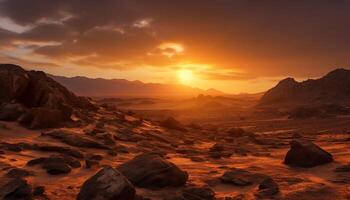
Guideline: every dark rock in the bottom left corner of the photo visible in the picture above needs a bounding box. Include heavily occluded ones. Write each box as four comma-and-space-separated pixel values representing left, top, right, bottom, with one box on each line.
0, 178, 32, 200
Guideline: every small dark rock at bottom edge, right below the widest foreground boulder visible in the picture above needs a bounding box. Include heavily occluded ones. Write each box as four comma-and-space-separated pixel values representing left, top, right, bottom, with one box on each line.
182, 187, 215, 200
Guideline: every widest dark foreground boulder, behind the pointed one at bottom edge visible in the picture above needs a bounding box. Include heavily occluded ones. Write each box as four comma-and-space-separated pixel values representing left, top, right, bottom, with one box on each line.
117, 153, 188, 188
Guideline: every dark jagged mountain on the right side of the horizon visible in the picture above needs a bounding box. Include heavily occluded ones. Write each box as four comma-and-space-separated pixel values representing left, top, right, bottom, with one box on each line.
259, 69, 350, 106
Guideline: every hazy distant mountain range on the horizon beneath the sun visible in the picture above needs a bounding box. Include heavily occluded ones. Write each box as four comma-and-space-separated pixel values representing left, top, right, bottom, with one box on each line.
50, 75, 225, 97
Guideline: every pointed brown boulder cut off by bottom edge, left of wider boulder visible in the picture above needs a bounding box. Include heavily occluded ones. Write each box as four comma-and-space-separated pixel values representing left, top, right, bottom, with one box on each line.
77, 167, 135, 200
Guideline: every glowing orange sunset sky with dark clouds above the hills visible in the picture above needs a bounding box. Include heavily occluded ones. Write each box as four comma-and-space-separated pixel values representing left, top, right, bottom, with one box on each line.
0, 0, 350, 93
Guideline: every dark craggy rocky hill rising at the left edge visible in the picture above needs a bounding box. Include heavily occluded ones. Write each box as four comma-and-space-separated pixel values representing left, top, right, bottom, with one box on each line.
0, 64, 94, 128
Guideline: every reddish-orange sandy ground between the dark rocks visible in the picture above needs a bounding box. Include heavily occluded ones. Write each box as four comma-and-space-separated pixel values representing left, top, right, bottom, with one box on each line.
0, 109, 350, 200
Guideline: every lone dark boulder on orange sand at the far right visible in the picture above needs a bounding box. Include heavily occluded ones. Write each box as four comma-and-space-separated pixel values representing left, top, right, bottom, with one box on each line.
284, 139, 333, 167
